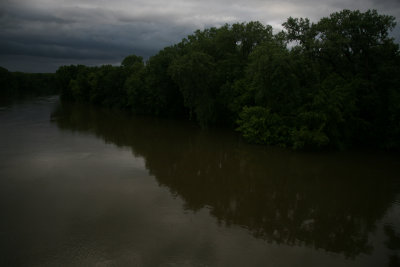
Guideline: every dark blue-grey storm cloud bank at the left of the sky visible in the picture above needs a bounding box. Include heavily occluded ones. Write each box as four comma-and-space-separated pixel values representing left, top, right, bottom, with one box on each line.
0, 0, 196, 71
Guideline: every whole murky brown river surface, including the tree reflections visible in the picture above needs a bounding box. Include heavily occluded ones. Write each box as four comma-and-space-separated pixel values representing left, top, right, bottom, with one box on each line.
0, 97, 400, 267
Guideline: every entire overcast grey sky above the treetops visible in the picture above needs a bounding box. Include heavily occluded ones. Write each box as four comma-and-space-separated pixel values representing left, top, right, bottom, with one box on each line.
0, 0, 400, 72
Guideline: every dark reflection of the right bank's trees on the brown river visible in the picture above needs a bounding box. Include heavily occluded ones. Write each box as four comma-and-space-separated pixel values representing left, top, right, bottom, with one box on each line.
52, 103, 398, 257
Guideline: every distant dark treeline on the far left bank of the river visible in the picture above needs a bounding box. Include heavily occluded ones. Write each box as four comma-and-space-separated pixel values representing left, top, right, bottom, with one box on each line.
0, 67, 58, 99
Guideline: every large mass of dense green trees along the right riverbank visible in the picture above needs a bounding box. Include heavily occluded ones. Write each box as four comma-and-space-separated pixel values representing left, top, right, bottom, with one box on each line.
57, 10, 400, 149
